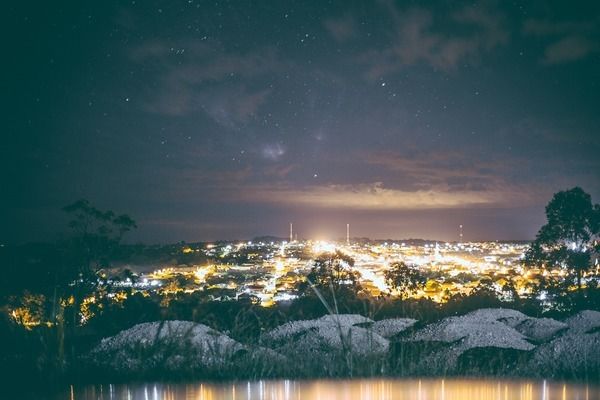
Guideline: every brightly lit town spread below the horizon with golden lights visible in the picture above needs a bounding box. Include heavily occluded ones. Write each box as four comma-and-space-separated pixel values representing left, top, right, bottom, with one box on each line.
10, 236, 600, 327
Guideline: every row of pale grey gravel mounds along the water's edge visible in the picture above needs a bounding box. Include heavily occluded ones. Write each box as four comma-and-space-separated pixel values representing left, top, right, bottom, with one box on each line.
87, 308, 600, 378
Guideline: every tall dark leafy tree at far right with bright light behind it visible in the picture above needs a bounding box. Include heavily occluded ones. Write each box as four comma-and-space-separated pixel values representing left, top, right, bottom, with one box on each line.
525, 187, 600, 289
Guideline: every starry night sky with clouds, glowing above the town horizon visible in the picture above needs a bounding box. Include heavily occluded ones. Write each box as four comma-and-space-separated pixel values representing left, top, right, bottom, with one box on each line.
0, 0, 600, 243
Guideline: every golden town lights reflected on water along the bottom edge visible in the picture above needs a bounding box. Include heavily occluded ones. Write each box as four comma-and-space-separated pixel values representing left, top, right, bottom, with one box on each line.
61, 379, 600, 400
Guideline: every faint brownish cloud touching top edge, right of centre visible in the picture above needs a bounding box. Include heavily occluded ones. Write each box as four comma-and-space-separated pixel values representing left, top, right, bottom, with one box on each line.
362, 2, 509, 79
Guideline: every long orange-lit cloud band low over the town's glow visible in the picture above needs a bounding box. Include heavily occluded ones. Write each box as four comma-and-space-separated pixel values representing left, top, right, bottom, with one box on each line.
200, 146, 546, 211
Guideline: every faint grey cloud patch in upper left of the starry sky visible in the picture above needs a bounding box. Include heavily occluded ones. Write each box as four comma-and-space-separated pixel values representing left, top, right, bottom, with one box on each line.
130, 39, 281, 124
